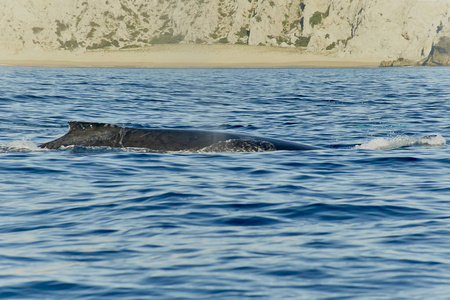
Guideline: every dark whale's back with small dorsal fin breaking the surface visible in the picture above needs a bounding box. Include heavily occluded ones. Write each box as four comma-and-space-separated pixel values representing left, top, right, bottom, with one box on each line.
39, 121, 320, 152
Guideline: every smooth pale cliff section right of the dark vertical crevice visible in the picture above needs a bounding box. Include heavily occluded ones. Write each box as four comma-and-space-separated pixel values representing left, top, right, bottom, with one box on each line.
308, 0, 450, 65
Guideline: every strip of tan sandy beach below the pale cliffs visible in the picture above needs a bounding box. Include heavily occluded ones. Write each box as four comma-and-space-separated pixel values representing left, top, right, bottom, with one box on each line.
0, 44, 382, 68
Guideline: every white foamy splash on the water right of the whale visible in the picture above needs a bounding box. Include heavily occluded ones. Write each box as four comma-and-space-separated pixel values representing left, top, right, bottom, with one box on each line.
355, 134, 446, 150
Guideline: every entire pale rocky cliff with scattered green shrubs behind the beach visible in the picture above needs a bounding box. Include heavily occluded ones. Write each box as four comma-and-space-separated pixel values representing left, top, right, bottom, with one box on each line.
0, 0, 450, 65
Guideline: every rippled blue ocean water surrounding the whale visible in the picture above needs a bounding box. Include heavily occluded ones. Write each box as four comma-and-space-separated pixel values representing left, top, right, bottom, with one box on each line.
0, 67, 450, 299
